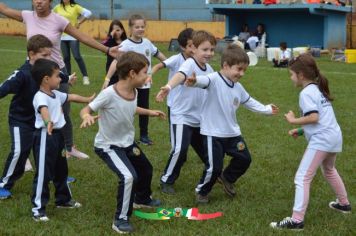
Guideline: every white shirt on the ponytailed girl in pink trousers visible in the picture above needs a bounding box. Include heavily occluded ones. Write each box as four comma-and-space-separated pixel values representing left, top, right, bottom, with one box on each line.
299, 84, 342, 152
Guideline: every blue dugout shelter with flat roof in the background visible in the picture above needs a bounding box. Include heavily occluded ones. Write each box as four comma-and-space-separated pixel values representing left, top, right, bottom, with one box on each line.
213, 4, 351, 48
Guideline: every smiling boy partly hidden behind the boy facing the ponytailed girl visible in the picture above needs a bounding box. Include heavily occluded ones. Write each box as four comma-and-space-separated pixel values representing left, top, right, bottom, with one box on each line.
156, 30, 216, 194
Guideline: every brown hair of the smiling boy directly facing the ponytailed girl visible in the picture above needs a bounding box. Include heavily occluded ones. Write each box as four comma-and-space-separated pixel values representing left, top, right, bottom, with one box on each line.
221, 43, 250, 67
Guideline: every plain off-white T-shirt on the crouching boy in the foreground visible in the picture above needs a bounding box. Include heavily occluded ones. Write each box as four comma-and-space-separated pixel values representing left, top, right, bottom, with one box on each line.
89, 86, 137, 148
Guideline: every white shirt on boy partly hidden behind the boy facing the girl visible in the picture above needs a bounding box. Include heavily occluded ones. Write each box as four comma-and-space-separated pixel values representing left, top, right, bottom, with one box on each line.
171, 58, 214, 127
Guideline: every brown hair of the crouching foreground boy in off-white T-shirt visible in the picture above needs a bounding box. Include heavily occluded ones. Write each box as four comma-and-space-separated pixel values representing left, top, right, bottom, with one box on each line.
116, 51, 150, 80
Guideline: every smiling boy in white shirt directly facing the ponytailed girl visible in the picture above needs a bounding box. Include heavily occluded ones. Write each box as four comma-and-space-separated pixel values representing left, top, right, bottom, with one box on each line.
186, 44, 278, 203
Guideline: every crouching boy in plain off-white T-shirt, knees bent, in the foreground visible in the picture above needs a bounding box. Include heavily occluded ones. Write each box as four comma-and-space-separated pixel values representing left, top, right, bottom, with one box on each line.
80, 52, 165, 233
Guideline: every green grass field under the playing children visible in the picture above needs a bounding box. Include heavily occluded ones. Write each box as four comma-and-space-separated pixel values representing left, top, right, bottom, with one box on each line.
0, 36, 356, 235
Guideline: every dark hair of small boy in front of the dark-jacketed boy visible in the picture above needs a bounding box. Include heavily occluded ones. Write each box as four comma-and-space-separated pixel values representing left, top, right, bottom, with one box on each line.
31, 58, 59, 85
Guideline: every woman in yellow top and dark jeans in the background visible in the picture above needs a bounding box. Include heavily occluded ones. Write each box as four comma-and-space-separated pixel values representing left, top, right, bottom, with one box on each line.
53, 0, 92, 85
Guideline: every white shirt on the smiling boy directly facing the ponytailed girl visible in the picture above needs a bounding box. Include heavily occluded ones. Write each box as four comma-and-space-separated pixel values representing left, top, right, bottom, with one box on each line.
195, 72, 272, 138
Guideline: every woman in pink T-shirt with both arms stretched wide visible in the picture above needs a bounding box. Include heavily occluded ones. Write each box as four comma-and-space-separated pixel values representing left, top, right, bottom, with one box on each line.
0, 0, 119, 158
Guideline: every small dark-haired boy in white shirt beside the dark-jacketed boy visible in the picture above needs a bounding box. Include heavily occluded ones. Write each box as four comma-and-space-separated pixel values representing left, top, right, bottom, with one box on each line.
31, 59, 95, 221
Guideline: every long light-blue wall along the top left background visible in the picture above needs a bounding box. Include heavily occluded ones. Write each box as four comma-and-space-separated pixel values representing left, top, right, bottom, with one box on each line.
2, 0, 218, 21
